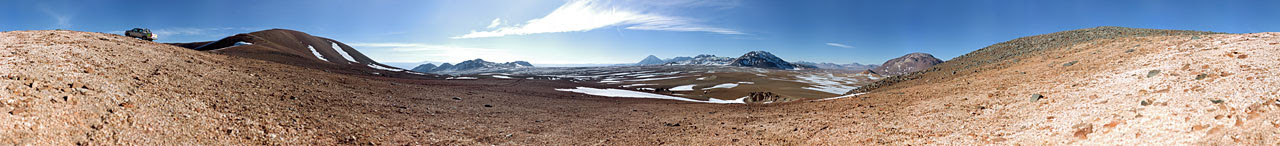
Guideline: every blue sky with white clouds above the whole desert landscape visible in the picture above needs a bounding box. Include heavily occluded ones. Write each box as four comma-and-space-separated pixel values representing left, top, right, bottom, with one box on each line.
0, 0, 1280, 64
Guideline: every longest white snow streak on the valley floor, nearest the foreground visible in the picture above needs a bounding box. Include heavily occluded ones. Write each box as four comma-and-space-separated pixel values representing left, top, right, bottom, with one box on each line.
556, 87, 745, 104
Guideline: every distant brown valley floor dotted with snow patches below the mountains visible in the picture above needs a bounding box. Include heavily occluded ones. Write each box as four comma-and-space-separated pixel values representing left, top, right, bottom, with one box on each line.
463, 65, 882, 101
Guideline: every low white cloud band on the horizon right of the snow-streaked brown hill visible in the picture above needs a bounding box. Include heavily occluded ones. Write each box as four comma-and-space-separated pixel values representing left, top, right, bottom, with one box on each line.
348, 44, 525, 63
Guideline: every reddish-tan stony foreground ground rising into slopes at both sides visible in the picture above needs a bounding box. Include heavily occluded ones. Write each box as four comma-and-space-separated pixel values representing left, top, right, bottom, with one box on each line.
0, 27, 1280, 145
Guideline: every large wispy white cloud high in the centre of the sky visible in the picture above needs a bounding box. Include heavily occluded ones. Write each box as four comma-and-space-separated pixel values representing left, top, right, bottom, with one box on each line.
451, 0, 744, 38
